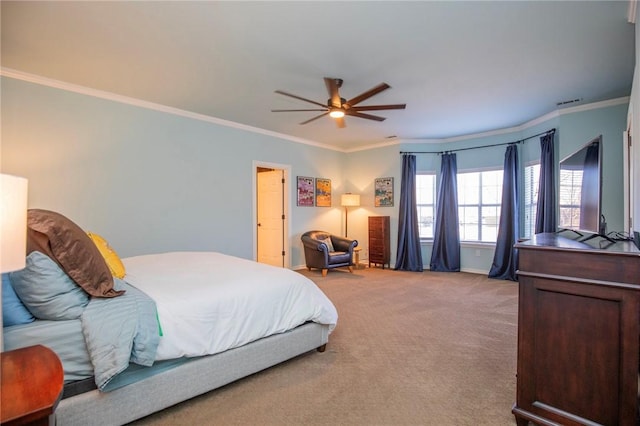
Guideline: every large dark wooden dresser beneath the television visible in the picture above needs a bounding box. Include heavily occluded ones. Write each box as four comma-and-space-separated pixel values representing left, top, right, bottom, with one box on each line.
513, 234, 640, 426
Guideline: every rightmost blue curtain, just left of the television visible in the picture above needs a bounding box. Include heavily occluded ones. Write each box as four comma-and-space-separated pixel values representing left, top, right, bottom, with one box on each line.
535, 132, 558, 234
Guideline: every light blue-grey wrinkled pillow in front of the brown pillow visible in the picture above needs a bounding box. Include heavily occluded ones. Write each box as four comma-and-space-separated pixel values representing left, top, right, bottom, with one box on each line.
9, 251, 89, 320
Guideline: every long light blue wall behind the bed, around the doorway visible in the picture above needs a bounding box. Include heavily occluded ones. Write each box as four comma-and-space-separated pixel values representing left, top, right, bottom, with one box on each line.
1, 78, 344, 265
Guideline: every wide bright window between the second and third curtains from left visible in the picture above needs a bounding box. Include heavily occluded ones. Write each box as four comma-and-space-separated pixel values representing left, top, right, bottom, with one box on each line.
457, 170, 502, 242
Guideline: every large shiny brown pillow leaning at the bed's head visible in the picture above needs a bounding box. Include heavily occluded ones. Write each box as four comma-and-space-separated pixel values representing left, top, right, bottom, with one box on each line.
27, 209, 124, 297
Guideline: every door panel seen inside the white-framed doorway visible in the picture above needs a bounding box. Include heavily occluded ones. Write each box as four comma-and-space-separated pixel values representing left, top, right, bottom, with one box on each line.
257, 170, 285, 267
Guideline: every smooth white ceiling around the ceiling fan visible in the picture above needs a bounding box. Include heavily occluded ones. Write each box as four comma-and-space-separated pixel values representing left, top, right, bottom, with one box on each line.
1, 1, 635, 151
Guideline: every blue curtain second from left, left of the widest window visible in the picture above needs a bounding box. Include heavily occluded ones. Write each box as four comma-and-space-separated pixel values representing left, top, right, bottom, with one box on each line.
430, 154, 460, 272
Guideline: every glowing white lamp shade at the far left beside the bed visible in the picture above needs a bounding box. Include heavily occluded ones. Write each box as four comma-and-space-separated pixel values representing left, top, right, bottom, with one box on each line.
0, 174, 28, 272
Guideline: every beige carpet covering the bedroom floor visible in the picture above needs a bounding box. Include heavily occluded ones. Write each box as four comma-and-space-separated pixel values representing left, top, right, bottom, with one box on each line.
130, 269, 518, 425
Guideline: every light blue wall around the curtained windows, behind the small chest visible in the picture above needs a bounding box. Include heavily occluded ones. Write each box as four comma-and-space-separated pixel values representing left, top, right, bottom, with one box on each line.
347, 103, 628, 273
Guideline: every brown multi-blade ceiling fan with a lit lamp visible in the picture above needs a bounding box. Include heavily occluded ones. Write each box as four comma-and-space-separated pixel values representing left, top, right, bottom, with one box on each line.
271, 77, 407, 128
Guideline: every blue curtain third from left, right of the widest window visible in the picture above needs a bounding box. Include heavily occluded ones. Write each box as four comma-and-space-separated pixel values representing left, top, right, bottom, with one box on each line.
489, 145, 520, 281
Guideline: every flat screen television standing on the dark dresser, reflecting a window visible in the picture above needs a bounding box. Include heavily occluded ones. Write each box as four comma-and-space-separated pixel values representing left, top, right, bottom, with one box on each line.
558, 135, 608, 239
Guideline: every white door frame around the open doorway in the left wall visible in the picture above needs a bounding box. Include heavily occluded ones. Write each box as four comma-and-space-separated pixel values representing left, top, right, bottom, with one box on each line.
251, 160, 292, 269
